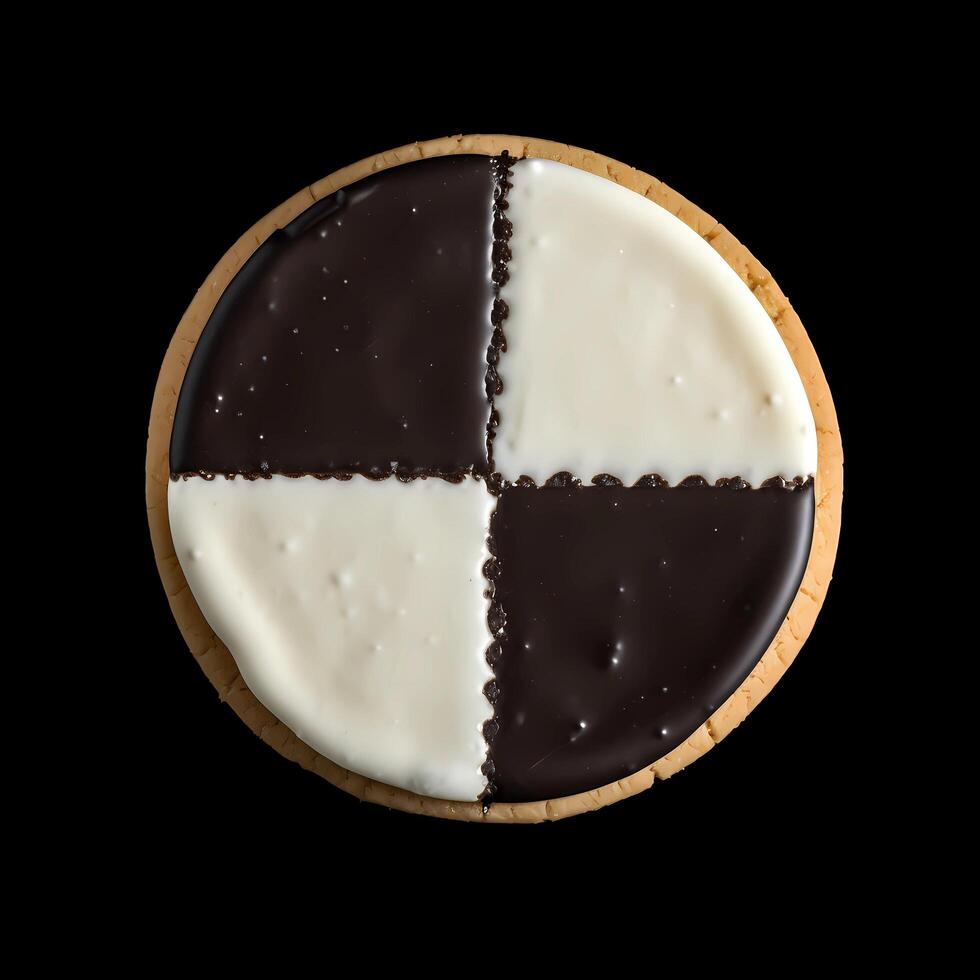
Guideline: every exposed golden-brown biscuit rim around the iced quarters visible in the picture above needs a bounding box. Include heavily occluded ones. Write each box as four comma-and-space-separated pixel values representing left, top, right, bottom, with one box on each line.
147, 137, 841, 821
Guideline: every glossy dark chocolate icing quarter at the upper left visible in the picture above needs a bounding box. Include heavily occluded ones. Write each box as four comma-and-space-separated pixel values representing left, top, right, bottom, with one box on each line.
170, 156, 498, 475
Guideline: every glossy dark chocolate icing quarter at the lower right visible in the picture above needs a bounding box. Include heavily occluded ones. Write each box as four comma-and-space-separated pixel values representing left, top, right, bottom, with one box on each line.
484, 479, 814, 802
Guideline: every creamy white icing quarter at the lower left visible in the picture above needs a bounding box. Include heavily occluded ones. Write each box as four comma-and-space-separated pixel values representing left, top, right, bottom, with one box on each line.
168, 476, 494, 800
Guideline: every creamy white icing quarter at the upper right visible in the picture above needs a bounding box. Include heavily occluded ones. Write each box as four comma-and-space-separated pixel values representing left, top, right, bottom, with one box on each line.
494, 160, 817, 486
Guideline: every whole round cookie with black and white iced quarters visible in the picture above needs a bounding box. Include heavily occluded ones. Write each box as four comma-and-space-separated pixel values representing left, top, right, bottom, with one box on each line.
147, 137, 840, 822
